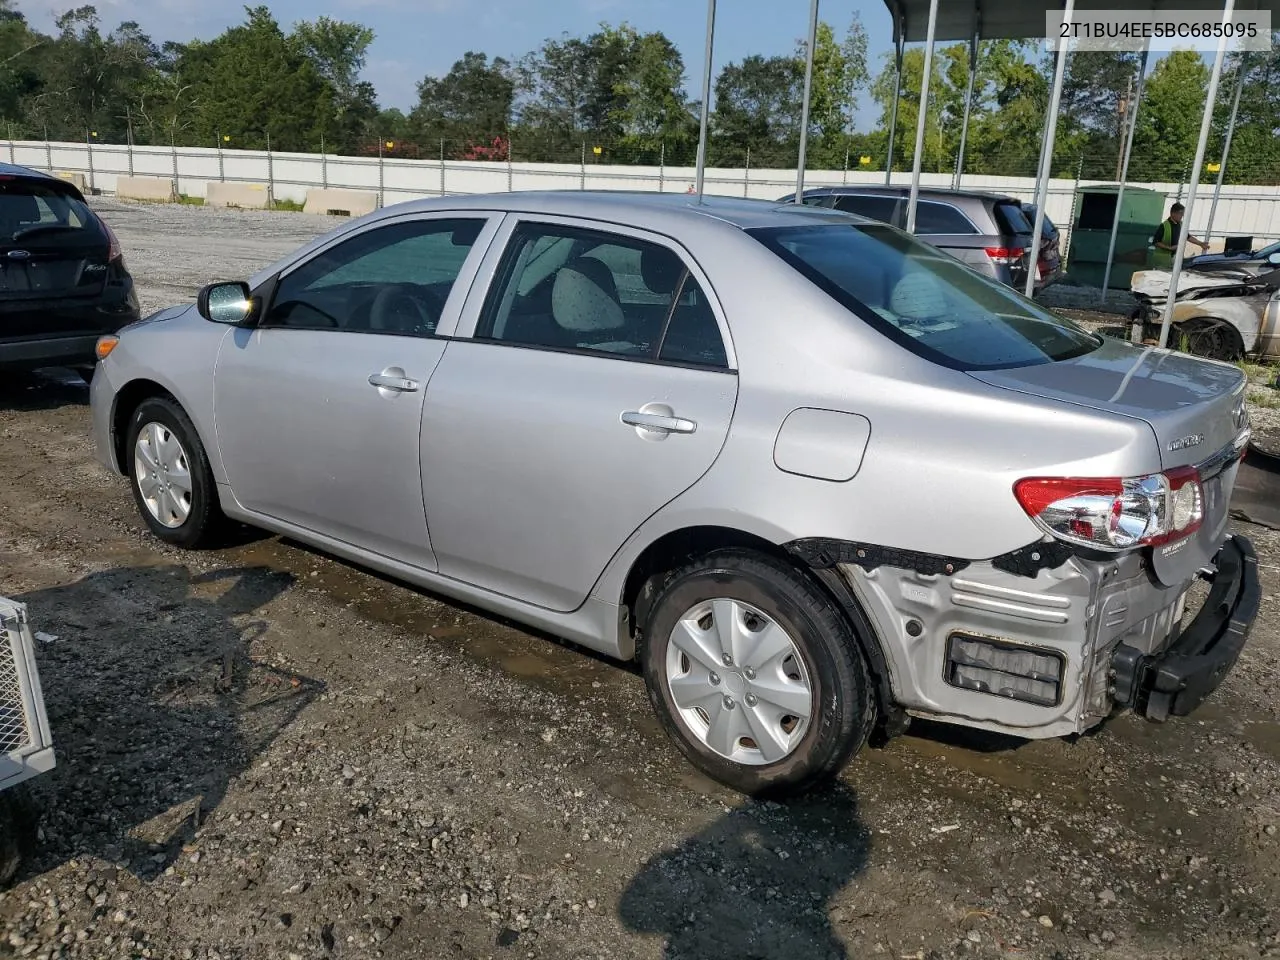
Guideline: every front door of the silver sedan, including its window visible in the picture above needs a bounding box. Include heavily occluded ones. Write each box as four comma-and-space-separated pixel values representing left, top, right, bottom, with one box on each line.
214, 211, 500, 570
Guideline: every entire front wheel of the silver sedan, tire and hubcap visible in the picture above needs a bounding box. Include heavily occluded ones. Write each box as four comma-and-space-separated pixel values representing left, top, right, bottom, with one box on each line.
127, 397, 225, 549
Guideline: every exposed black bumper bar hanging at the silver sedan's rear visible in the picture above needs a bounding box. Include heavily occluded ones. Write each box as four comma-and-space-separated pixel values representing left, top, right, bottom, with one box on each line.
1112, 536, 1262, 721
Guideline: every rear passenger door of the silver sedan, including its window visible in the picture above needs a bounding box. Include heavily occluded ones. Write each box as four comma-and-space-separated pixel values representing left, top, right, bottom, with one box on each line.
422, 216, 737, 611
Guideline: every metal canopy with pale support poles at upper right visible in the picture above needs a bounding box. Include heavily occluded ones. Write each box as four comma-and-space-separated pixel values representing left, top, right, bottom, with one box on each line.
880, 0, 1280, 347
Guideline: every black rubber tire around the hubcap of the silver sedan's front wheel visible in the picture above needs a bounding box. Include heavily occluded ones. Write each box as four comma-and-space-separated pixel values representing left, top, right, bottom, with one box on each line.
124, 397, 227, 549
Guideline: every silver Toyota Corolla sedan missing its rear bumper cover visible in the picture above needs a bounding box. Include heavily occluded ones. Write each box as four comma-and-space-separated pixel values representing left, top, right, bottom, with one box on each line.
91, 192, 1260, 794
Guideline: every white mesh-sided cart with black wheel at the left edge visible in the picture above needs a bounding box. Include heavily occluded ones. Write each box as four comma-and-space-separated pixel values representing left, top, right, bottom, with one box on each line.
0, 596, 54, 888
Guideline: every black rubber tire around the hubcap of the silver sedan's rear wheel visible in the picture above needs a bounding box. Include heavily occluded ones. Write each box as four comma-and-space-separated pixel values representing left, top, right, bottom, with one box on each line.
640, 549, 876, 796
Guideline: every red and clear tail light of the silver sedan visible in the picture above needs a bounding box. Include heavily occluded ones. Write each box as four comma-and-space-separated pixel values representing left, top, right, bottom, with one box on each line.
1014, 467, 1204, 550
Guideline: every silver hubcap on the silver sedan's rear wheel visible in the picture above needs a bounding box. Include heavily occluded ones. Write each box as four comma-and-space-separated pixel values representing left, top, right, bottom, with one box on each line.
667, 599, 813, 765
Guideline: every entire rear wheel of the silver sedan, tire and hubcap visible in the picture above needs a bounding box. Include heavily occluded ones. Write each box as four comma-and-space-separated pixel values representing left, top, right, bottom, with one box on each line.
641, 550, 876, 795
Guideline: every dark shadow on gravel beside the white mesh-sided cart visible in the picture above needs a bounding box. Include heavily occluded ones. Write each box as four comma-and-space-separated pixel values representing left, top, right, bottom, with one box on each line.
14, 566, 323, 879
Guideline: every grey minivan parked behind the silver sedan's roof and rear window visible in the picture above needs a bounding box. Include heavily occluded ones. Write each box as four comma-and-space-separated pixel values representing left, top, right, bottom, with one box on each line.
780, 186, 1036, 289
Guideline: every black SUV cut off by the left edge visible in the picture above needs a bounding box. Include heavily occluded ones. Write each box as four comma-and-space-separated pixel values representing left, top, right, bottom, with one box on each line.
0, 164, 140, 380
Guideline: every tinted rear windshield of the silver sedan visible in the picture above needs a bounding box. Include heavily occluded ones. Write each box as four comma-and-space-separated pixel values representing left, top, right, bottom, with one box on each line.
749, 224, 1102, 370
